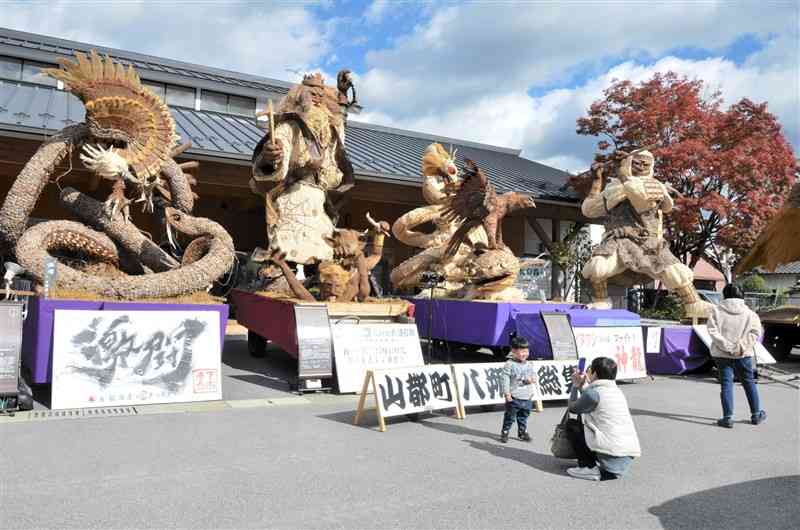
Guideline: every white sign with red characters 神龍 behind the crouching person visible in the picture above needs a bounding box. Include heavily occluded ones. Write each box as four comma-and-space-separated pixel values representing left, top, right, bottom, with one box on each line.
573, 327, 647, 379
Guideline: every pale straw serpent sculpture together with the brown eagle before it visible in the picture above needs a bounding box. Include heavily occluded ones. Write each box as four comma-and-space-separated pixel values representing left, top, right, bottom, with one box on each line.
391, 144, 535, 300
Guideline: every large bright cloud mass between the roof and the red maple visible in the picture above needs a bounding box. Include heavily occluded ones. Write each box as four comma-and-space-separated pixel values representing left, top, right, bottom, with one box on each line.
359, 2, 800, 171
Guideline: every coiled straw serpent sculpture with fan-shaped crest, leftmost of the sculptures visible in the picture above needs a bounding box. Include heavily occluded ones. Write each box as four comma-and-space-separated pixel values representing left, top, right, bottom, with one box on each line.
0, 51, 235, 299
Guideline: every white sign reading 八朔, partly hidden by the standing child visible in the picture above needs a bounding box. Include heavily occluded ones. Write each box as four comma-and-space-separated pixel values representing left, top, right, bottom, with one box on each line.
453, 360, 578, 407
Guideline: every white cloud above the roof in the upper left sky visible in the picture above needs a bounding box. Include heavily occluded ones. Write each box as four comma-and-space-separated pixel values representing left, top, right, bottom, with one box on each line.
2, 1, 333, 79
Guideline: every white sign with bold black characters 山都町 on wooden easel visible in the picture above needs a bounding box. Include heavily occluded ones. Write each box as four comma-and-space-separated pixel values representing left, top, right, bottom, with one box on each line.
373, 364, 457, 417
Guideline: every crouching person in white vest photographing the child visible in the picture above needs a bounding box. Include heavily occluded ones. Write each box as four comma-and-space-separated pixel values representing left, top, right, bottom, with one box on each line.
567, 357, 641, 480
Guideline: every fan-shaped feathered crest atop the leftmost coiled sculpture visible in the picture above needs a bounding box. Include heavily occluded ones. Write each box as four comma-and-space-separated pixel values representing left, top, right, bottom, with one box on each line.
42, 50, 177, 182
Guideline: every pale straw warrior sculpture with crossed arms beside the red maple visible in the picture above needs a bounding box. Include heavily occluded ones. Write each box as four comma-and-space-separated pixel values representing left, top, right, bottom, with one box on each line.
581, 149, 708, 317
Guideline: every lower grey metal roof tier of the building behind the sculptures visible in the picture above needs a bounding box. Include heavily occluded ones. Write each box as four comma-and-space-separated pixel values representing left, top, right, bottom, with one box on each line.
0, 80, 577, 202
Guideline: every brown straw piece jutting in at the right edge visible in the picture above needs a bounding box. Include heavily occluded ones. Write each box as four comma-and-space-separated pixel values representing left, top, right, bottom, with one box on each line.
736, 182, 800, 274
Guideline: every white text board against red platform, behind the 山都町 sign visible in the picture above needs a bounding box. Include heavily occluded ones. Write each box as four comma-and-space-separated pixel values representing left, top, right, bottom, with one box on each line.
332, 323, 424, 392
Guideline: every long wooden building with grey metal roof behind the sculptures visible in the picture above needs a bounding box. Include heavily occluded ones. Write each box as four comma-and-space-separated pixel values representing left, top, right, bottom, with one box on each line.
0, 28, 582, 292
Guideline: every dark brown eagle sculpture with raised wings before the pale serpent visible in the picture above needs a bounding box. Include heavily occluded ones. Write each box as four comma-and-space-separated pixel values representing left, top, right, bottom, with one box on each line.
442, 159, 536, 257
